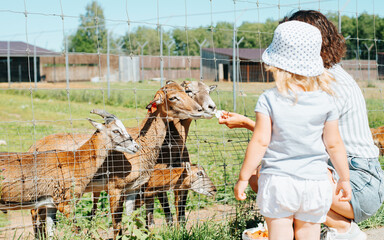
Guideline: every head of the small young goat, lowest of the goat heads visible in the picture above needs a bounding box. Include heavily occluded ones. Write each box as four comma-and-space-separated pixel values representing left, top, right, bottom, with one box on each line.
185, 162, 217, 197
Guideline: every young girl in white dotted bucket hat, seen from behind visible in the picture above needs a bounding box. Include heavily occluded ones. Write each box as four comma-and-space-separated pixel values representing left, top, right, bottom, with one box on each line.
234, 21, 351, 240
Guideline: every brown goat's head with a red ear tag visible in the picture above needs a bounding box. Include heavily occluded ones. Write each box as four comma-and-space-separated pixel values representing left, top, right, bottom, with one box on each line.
146, 82, 203, 121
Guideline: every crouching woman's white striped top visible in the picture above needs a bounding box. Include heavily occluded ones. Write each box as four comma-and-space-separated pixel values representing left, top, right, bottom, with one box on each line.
328, 64, 379, 158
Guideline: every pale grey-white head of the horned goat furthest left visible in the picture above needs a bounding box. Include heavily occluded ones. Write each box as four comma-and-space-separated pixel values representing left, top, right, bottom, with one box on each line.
88, 109, 139, 154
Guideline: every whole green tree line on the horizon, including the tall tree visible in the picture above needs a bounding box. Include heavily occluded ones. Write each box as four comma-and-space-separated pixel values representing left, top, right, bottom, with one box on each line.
68, 1, 384, 59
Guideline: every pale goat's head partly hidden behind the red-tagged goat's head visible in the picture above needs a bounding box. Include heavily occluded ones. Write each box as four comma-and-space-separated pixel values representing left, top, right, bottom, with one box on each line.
181, 81, 217, 119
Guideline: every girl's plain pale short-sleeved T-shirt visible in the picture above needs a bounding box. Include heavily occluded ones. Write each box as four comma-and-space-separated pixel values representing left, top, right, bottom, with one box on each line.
255, 88, 338, 180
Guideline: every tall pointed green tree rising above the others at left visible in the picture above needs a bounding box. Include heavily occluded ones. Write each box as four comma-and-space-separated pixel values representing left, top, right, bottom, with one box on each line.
68, 1, 107, 53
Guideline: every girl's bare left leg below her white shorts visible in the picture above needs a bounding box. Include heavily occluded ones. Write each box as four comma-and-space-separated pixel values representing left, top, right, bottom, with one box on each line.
265, 216, 292, 240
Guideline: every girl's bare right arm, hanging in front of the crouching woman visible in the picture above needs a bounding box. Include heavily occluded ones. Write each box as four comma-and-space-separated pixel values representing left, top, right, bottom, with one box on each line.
323, 120, 352, 201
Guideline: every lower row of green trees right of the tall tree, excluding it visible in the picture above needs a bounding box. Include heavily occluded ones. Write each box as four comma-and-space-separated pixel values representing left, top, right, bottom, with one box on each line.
117, 13, 384, 59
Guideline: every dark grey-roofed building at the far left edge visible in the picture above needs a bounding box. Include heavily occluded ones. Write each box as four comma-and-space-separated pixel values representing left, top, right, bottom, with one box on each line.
0, 41, 60, 82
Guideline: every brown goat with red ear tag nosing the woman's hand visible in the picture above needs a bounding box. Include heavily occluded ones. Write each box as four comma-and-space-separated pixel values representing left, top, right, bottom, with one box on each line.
30, 82, 203, 238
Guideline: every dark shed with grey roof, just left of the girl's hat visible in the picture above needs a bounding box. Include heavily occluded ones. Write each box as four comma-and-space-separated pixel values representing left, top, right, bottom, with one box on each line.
201, 48, 273, 82
